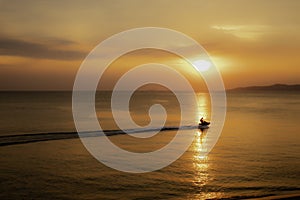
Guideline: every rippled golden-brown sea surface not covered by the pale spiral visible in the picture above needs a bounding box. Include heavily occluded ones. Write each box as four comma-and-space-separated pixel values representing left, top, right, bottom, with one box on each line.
0, 91, 300, 200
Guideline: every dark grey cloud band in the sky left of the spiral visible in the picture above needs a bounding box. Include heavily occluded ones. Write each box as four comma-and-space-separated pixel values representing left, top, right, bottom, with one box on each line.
0, 37, 86, 60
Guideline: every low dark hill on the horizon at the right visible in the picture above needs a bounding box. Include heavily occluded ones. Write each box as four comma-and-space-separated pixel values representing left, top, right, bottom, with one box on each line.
228, 84, 300, 91
